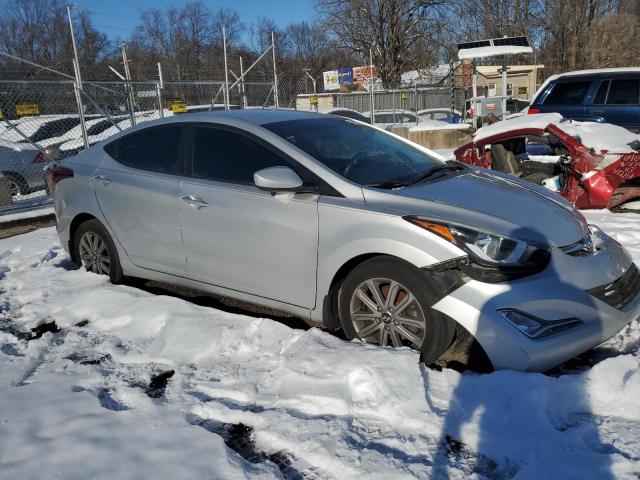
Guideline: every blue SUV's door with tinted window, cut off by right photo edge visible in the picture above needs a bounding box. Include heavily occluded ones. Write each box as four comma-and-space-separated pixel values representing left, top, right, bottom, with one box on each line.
588, 76, 640, 130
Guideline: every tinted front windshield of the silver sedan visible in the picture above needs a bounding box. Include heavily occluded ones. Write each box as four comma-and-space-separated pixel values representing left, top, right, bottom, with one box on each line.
264, 118, 445, 187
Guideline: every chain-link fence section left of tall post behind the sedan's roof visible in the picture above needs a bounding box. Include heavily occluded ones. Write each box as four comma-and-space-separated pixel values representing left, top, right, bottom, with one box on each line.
0, 80, 275, 215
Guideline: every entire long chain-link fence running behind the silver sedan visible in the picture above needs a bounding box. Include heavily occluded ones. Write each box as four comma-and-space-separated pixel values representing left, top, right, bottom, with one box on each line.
0, 70, 467, 215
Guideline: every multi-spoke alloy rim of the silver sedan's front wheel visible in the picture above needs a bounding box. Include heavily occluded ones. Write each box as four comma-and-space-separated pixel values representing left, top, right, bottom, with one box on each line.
350, 278, 426, 350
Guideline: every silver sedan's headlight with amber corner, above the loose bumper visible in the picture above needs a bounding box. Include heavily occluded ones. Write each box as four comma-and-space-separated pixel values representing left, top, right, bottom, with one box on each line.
405, 217, 550, 283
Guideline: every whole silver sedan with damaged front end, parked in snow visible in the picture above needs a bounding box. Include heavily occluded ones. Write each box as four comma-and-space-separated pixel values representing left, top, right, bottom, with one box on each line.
51, 110, 640, 370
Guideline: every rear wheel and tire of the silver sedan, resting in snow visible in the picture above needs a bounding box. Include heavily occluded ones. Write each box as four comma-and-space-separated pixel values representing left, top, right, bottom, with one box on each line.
73, 220, 123, 283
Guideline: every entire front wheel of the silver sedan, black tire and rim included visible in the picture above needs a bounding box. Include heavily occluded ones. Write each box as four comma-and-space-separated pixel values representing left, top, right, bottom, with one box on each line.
338, 257, 455, 364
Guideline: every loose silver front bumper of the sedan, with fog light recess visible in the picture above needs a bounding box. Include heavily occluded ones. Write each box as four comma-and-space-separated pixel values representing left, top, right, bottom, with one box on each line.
433, 232, 640, 371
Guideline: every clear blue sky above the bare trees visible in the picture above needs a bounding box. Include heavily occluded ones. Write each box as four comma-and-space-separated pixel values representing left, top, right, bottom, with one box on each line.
74, 0, 315, 39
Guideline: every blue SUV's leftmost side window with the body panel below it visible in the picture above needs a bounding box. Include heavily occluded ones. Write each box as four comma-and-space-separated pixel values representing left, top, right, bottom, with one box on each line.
535, 78, 594, 120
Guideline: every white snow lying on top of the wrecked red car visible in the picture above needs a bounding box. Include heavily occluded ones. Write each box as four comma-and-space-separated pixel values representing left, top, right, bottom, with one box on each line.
474, 113, 640, 153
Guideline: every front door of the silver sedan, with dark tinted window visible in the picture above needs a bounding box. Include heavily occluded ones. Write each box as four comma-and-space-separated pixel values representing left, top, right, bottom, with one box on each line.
180, 124, 318, 308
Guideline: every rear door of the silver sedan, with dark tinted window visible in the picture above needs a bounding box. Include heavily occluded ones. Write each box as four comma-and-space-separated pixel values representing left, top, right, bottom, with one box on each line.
91, 124, 185, 276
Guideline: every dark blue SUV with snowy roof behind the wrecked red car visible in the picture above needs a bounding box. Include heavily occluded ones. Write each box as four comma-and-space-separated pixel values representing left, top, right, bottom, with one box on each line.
528, 68, 640, 133
